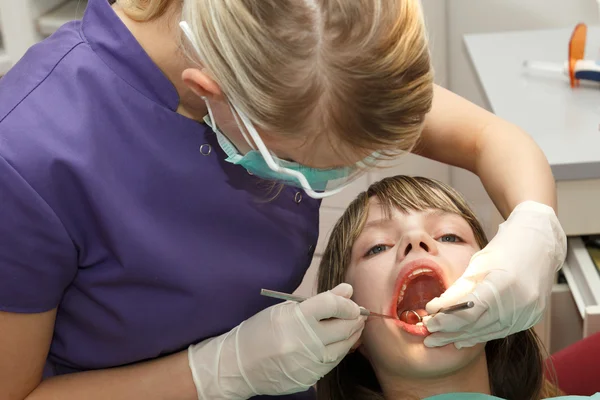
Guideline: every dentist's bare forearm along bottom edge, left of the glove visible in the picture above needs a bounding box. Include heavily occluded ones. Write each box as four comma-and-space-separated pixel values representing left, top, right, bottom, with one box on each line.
25, 351, 198, 400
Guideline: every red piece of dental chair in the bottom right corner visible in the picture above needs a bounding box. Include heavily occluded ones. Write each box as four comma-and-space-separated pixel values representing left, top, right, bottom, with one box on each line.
546, 333, 600, 396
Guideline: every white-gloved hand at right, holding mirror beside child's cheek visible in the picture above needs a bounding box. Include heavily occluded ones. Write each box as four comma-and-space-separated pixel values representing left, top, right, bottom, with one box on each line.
424, 201, 567, 349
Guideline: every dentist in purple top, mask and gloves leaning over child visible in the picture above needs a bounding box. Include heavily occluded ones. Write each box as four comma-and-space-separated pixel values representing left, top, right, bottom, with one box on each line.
0, 0, 566, 400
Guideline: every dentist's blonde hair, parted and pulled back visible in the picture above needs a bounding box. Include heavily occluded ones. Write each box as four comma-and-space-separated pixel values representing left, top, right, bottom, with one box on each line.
179, 0, 433, 162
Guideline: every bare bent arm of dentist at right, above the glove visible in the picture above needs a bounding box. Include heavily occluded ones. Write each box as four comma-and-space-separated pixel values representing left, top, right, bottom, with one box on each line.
416, 86, 556, 218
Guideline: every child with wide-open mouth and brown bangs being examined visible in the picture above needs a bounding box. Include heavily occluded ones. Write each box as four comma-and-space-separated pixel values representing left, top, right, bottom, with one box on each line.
317, 176, 560, 400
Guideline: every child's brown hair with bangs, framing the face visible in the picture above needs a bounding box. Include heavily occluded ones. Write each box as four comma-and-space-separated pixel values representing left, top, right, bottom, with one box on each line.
317, 176, 561, 400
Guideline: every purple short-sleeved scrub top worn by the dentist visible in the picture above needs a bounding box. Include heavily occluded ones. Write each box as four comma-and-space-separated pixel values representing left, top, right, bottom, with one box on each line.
0, 0, 320, 399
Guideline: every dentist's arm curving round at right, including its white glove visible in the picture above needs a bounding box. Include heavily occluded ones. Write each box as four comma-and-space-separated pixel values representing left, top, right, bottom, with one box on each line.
417, 83, 566, 348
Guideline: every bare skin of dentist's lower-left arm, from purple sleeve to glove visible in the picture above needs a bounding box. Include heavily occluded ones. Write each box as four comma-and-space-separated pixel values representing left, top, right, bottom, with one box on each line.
0, 310, 198, 400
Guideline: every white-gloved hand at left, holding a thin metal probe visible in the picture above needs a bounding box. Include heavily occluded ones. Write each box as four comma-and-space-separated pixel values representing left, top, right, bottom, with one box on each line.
188, 283, 366, 399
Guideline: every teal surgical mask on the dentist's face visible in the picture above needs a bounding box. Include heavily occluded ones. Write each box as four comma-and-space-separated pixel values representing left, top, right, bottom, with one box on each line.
179, 22, 376, 199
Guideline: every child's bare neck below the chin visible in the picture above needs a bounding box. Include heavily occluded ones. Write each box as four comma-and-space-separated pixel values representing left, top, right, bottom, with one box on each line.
377, 352, 491, 400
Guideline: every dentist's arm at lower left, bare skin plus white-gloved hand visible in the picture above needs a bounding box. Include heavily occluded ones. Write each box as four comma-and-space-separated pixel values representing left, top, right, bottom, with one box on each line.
0, 284, 366, 400
